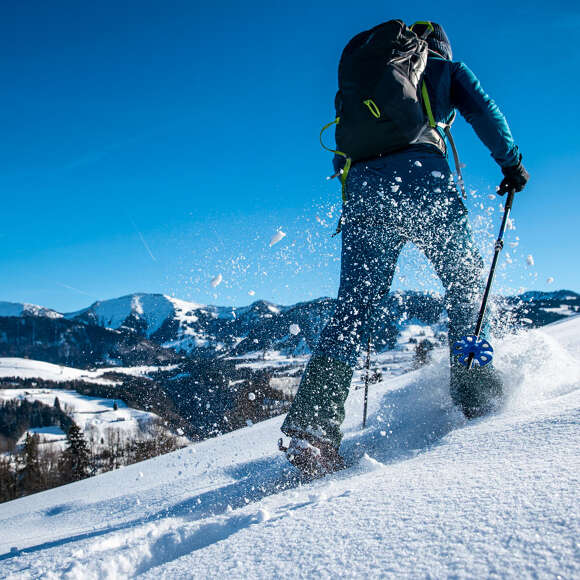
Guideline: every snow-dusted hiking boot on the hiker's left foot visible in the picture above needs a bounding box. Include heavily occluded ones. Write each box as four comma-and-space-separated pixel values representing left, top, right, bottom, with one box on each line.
278, 437, 346, 479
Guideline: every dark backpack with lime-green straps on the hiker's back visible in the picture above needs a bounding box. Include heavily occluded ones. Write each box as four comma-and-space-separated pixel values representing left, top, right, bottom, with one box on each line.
320, 20, 435, 198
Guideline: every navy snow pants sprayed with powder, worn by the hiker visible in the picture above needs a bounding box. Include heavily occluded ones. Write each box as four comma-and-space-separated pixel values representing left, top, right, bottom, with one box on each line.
282, 149, 483, 444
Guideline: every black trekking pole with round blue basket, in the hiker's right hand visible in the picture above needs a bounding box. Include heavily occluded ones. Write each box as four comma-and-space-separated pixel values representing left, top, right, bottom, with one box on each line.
453, 189, 516, 370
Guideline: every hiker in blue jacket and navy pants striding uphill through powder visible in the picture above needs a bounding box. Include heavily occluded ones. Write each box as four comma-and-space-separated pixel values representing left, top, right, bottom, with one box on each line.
280, 22, 529, 476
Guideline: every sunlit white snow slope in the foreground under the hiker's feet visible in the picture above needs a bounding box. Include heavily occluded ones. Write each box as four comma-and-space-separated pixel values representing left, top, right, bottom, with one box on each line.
0, 317, 580, 579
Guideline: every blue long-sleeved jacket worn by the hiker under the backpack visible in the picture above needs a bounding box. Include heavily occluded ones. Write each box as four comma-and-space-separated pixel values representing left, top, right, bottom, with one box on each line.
334, 52, 520, 171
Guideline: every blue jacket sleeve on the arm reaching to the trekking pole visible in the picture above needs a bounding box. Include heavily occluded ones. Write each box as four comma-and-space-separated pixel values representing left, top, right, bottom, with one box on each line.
451, 62, 520, 167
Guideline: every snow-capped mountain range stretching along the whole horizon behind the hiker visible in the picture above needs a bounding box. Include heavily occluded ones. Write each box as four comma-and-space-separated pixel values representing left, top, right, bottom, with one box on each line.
0, 290, 580, 367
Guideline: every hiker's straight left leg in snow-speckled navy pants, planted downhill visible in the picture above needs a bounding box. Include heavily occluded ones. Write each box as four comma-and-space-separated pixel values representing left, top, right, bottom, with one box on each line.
282, 173, 404, 448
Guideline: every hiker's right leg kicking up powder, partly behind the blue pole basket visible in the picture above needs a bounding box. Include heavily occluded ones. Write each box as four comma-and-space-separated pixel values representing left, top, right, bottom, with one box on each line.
413, 165, 502, 418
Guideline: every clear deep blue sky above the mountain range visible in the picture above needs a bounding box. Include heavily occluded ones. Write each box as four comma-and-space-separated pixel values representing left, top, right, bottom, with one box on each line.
0, 0, 580, 311
